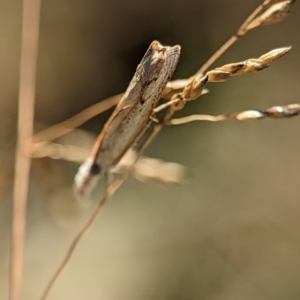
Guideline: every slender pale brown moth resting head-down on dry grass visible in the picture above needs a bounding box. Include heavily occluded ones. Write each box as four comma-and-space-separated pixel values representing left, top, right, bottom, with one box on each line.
75, 41, 180, 198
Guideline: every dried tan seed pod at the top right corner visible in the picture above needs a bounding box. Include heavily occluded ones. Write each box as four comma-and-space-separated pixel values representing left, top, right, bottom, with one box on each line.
246, 0, 295, 30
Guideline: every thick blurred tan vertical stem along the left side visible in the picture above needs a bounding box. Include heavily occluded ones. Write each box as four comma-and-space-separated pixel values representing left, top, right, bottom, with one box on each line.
9, 0, 40, 300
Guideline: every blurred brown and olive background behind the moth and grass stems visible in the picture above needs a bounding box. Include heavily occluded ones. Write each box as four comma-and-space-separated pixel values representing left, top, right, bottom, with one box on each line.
0, 0, 300, 300
